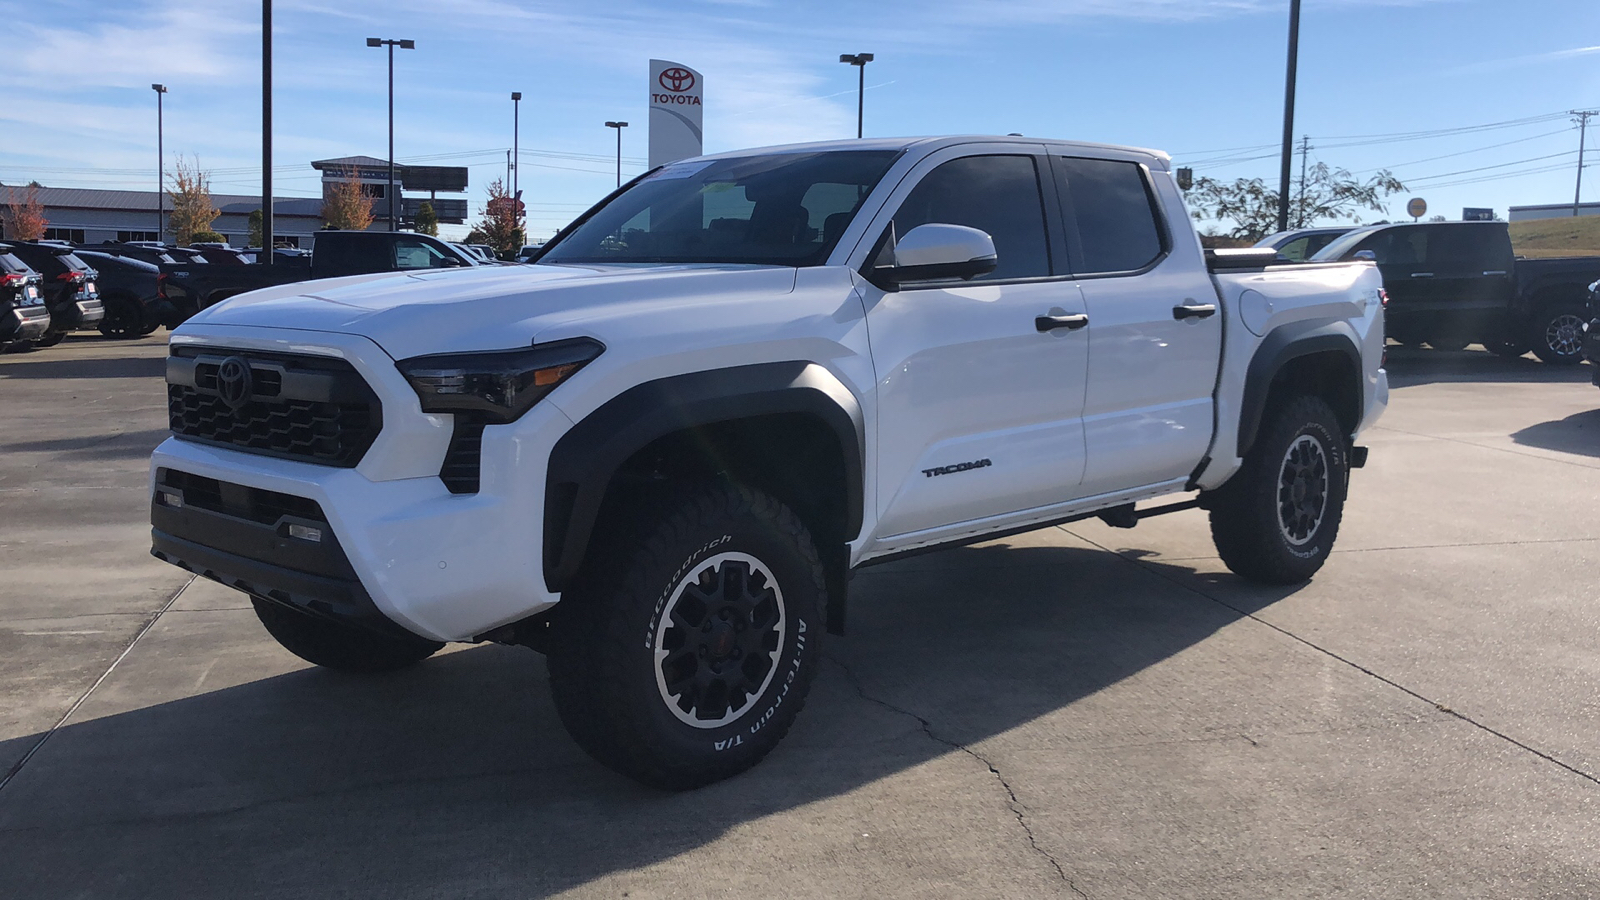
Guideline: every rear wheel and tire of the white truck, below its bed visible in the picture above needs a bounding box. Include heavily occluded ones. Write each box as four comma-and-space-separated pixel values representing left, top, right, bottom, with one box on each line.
1205, 396, 1350, 585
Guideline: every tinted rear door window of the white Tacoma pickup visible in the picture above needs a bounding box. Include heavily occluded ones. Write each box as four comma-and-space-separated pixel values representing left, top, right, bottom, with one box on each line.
1056, 157, 1166, 275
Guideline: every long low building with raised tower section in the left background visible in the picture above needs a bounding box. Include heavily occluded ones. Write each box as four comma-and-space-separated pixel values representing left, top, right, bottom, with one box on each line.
0, 157, 467, 248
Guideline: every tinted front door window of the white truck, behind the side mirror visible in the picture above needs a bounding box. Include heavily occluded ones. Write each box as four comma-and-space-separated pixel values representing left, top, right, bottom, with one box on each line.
889, 155, 1051, 282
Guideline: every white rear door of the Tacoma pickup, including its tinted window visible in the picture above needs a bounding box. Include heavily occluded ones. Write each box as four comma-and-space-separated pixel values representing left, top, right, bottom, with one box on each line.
1053, 157, 1222, 495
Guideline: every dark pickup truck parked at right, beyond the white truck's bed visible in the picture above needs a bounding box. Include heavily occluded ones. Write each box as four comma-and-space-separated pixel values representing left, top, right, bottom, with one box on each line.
1312, 223, 1600, 364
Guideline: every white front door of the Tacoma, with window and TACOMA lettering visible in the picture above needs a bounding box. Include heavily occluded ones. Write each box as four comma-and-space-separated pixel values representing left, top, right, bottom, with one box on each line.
862, 146, 1088, 544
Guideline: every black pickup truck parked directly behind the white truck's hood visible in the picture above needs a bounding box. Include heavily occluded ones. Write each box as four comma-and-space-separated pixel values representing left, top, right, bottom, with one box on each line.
162, 231, 477, 327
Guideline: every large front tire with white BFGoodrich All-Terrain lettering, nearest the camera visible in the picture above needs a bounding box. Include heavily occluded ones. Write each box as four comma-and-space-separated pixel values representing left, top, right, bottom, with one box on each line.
549, 480, 827, 791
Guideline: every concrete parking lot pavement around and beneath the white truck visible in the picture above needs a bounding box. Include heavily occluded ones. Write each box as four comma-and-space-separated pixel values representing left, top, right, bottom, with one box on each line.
0, 335, 1600, 900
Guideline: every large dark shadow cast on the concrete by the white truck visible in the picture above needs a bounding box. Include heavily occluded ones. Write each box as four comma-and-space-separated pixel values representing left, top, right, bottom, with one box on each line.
0, 533, 1293, 898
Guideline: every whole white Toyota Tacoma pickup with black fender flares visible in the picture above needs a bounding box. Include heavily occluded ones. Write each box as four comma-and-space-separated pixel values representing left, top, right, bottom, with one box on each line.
150, 136, 1389, 790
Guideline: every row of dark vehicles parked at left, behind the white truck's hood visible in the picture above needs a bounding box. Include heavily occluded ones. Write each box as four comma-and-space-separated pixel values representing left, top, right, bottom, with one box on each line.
0, 231, 534, 349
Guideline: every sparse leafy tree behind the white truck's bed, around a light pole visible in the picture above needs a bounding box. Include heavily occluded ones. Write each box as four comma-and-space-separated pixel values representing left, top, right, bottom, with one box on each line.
1184, 162, 1405, 242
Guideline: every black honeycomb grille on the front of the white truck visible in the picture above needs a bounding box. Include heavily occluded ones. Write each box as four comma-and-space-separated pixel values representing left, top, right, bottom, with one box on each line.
166, 346, 382, 468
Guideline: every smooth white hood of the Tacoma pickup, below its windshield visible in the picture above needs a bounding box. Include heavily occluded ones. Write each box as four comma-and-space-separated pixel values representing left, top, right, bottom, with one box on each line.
190, 264, 797, 359
